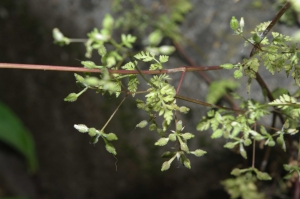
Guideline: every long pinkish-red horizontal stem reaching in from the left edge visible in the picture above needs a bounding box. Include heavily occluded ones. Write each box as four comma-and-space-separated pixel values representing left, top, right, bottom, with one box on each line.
0, 63, 222, 75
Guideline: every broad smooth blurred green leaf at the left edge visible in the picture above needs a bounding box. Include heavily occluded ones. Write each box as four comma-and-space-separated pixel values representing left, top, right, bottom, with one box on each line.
0, 102, 38, 173
